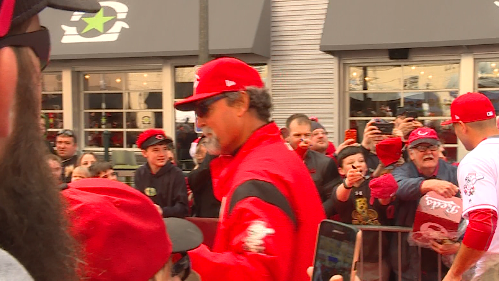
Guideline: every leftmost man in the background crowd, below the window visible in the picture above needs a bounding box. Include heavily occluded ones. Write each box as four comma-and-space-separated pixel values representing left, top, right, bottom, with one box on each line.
55, 129, 78, 183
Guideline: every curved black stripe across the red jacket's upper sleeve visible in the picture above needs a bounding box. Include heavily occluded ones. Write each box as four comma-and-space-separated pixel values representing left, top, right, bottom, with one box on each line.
228, 180, 298, 228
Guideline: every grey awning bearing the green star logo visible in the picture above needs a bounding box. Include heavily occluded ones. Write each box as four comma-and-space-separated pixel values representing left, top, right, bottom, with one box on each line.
40, 0, 270, 59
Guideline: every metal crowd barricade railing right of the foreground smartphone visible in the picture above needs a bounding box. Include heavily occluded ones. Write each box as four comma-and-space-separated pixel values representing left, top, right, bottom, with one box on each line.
354, 225, 442, 281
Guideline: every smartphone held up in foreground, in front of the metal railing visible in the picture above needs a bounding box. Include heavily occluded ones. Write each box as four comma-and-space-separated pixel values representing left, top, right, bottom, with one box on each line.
312, 220, 362, 281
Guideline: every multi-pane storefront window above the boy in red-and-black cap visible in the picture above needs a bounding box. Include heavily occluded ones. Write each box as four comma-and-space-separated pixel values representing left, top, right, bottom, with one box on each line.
82, 72, 163, 148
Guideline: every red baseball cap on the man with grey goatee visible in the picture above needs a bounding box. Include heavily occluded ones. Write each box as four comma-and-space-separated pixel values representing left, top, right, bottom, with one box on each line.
175, 58, 264, 111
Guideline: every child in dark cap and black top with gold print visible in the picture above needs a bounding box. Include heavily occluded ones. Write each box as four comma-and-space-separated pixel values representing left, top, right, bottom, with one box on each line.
331, 146, 396, 281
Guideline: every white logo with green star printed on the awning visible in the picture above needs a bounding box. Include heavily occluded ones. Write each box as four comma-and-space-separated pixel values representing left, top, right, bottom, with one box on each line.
61, 1, 129, 43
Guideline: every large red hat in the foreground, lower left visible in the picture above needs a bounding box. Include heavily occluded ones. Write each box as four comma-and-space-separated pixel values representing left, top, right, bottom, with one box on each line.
62, 178, 202, 281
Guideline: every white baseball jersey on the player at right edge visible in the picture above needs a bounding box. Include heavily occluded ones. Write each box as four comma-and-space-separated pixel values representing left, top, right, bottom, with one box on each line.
457, 137, 499, 267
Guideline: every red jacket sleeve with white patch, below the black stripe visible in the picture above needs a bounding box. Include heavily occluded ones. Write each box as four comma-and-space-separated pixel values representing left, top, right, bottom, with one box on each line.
189, 197, 296, 281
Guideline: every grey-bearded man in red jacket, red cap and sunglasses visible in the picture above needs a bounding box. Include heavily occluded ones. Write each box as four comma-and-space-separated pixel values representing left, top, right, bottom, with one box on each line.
175, 58, 325, 281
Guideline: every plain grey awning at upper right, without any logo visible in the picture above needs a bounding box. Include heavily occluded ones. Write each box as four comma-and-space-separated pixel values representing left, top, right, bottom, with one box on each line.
320, 0, 499, 52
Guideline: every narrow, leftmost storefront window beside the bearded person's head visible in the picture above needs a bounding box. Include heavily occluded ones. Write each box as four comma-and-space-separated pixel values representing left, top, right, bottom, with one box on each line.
42, 72, 64, 145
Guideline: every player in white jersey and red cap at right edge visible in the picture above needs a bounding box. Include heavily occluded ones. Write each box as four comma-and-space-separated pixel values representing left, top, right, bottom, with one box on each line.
442, 93, 499, 281
